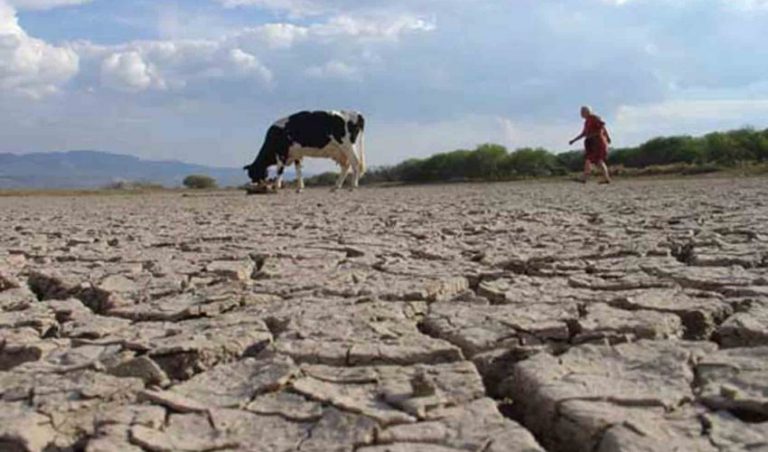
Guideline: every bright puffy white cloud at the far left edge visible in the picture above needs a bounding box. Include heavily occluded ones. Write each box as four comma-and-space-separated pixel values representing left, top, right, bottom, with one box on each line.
0, 0, 79, 98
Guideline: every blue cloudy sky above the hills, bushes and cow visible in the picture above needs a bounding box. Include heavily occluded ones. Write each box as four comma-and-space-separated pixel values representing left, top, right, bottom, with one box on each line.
0, 0, 768, 170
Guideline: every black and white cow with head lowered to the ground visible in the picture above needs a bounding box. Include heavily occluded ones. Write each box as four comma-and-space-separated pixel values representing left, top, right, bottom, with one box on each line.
243, 111, 365, 192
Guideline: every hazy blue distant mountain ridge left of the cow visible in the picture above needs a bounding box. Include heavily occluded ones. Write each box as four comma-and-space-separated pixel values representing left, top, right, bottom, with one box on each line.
0, 151, 282, 188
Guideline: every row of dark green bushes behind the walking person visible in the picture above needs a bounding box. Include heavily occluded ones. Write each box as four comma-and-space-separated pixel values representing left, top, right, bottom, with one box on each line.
306, 128, 768, 186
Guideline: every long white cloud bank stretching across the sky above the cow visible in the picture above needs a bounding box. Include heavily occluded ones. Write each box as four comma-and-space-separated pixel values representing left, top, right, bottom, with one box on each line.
75, 10, 434, 92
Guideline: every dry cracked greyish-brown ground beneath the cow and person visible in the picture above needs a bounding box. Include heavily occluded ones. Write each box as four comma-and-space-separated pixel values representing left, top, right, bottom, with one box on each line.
0, 179, 768, 452
